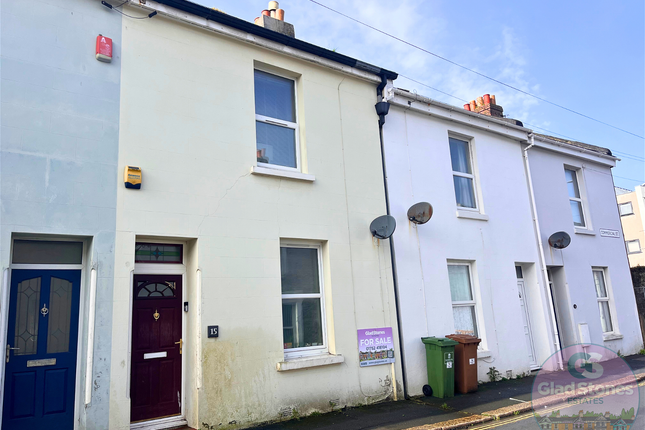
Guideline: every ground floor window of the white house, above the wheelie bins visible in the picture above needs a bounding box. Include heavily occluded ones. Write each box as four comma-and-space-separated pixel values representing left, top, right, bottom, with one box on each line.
448, 263, 479, 337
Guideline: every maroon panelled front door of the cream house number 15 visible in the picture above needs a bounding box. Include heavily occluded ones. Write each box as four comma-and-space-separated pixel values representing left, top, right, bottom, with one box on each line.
130, 275, 182, 422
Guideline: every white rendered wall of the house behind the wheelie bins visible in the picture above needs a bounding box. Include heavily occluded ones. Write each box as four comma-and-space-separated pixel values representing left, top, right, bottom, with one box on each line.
384, 96, 552, 395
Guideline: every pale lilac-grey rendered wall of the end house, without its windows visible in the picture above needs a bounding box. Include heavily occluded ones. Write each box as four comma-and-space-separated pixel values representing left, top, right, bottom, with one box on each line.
529, 146, 643, 355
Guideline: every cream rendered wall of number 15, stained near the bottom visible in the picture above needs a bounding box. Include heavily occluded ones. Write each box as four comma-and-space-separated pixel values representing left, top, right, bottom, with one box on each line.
110, 11, 402, 429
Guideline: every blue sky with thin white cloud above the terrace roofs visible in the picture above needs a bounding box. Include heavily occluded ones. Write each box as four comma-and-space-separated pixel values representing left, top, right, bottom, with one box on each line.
193, 0, 645, 189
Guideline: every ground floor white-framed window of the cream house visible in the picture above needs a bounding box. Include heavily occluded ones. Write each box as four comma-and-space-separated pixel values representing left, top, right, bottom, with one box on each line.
280, 244, 326, 358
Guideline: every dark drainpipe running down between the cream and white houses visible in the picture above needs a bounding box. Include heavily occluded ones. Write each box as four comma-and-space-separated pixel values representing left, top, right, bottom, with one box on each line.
375, 75, 409, 399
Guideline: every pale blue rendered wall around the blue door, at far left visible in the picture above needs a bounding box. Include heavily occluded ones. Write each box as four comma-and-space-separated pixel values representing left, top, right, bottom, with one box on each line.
0, 0, 121, 429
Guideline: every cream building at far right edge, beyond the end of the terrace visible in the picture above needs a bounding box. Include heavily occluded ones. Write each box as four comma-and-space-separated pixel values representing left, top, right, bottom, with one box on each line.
616, 185, 645, 267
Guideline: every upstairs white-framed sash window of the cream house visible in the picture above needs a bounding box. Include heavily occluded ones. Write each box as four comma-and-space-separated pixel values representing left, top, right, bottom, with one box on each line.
255, 70, 300, 171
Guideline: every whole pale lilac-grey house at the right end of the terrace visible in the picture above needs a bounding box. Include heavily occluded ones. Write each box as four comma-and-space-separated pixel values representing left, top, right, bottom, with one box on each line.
527, 134, 643, 355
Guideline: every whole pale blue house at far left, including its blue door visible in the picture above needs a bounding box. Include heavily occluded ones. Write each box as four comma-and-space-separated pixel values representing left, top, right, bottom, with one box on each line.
0, 0, 122, 430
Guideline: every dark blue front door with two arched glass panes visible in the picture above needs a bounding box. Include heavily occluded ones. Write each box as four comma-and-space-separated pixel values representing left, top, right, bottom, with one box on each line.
2, 270, 81, 430
